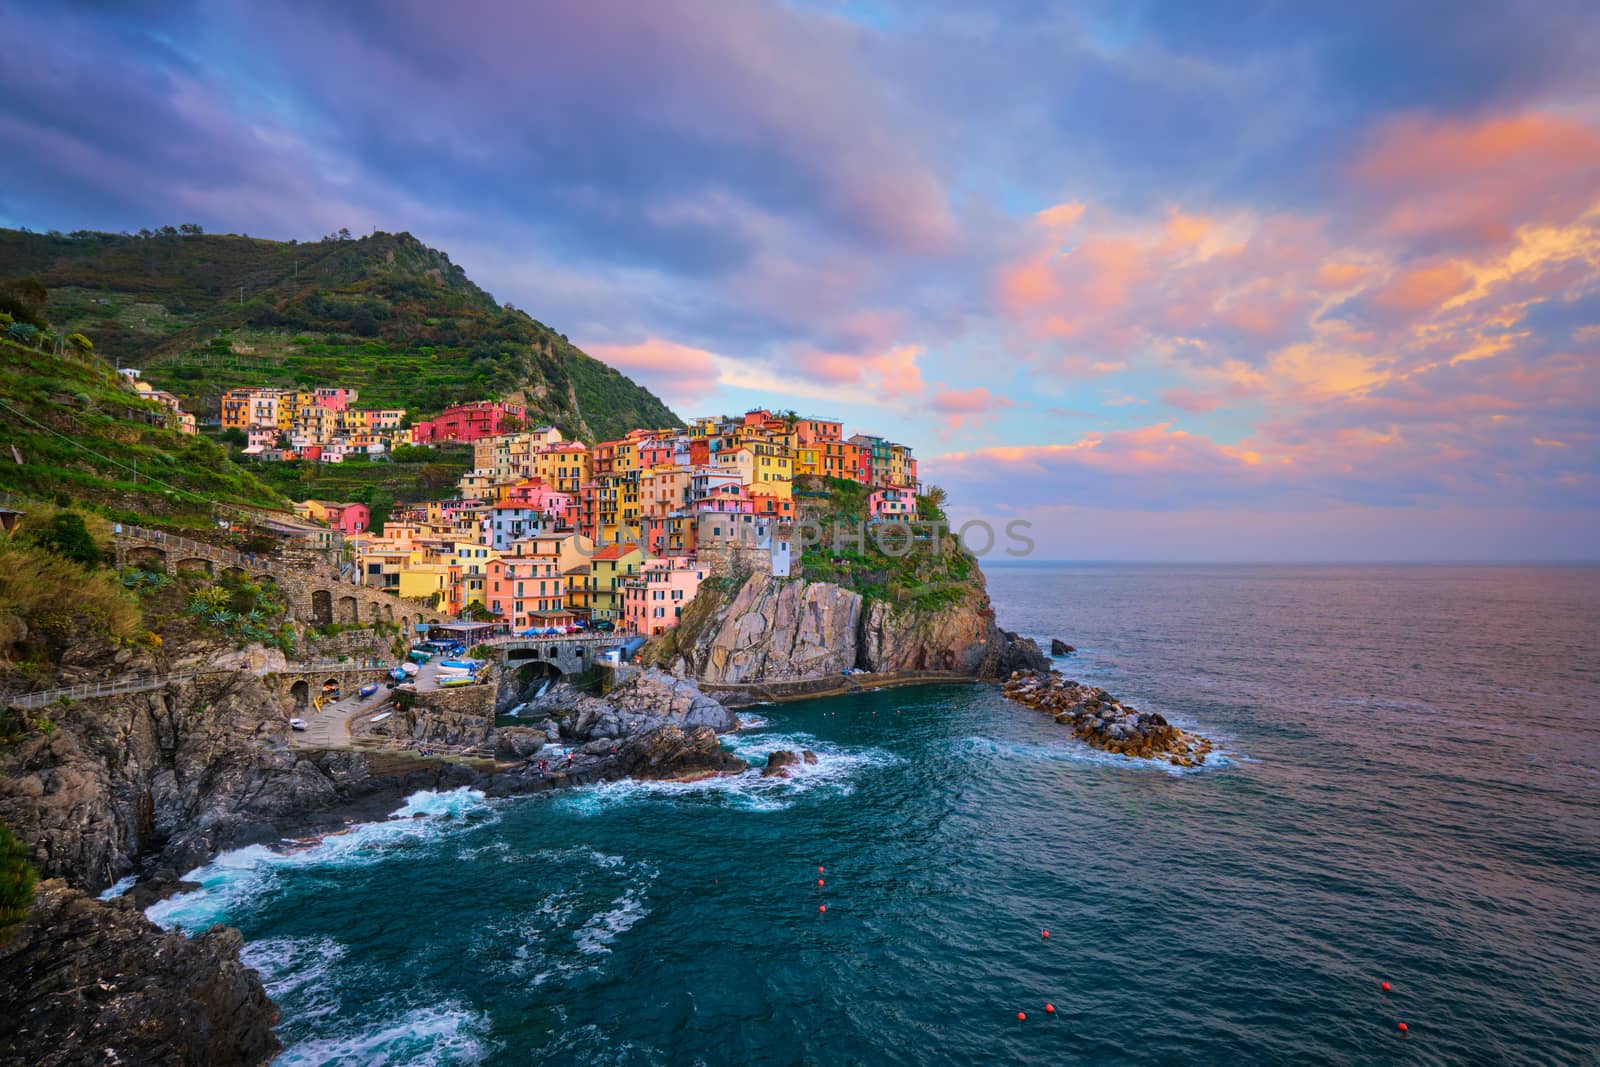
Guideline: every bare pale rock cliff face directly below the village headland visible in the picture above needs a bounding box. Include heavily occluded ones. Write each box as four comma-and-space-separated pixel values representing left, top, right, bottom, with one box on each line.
650, 568, 1046, 683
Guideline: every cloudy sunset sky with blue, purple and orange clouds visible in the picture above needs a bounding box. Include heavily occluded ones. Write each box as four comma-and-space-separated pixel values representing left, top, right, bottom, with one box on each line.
0, 0, 1600, 560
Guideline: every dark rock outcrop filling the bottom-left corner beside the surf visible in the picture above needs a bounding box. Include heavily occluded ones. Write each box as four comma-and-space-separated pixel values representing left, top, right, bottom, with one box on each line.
0, 880, 280, 1067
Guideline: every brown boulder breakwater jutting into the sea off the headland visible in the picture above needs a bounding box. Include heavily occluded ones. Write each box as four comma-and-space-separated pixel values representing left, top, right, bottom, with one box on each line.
1003, 670, 1216, 766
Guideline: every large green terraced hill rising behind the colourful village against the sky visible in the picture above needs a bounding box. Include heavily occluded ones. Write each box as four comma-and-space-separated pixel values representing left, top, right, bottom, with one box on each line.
0, 227, 682, 440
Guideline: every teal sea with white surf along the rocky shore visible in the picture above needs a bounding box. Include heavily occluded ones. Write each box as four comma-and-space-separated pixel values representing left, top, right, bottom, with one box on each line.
140, 563, 1600, 1065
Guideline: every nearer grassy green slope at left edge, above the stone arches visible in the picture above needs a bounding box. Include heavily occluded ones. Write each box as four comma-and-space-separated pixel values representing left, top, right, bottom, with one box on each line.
0, 338, 286, 528
